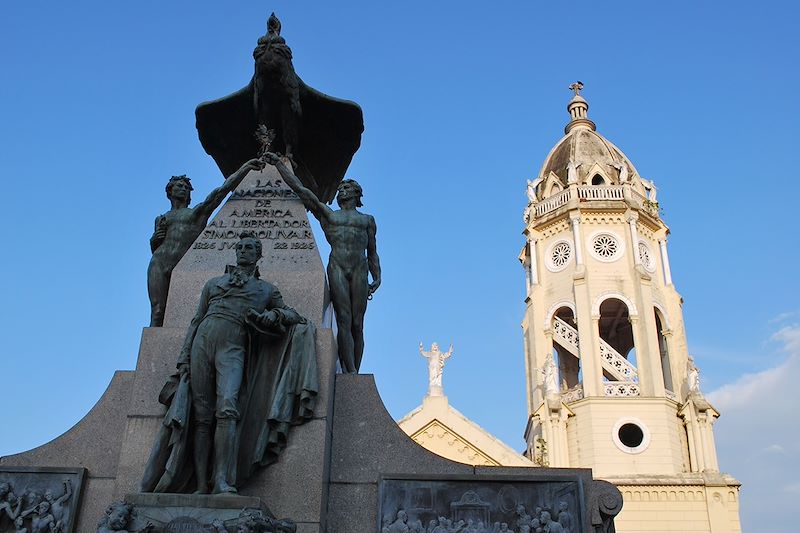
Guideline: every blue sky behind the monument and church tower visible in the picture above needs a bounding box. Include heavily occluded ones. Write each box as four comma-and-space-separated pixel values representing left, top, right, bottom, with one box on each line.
0, 1, 800, 531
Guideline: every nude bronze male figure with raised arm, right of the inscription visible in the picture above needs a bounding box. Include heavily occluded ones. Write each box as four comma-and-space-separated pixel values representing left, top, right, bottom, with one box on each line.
265, 153, 381, 374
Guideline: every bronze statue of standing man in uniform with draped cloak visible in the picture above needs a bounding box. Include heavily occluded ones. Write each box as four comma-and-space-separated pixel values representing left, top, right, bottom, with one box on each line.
141, 232, 319, 494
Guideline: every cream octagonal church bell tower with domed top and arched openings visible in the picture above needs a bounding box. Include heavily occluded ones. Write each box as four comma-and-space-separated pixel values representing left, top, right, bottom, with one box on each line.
520, 82, 741, 532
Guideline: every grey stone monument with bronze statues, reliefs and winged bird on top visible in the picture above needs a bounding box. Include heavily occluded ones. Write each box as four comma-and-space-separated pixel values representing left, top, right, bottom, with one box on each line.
0, 14, 622, 533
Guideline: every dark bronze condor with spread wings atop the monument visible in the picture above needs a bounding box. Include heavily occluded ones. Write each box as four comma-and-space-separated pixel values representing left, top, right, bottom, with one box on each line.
195, 13, 364, 203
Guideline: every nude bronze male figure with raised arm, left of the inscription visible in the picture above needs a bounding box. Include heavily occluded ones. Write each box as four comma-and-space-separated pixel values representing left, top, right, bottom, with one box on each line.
147, 159, 264, 327
